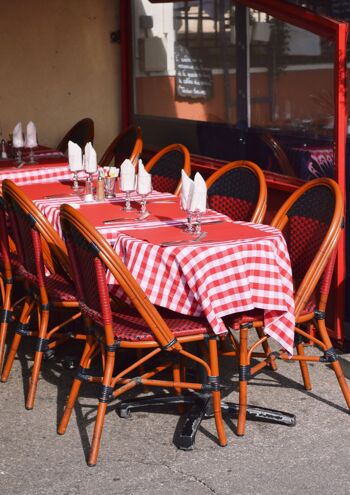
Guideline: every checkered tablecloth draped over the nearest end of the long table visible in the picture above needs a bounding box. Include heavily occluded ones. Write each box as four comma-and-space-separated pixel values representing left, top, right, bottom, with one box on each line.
108, 221, 295, 355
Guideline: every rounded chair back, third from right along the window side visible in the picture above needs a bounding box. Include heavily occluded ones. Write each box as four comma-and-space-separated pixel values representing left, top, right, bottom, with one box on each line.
145, 144, 191, 196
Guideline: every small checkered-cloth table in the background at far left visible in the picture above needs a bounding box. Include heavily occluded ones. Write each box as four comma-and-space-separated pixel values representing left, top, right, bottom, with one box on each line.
0, 146, 72, 186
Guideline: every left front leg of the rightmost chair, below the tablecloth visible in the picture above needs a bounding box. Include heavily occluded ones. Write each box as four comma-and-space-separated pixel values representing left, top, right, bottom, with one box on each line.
237, 325, 249, 436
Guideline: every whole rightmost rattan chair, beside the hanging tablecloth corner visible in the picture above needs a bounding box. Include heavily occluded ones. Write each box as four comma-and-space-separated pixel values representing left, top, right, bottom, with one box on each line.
226, 178, 350, 435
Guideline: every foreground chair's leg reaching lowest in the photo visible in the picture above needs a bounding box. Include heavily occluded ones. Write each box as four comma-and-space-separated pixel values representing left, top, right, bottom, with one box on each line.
88, 352, 115, 466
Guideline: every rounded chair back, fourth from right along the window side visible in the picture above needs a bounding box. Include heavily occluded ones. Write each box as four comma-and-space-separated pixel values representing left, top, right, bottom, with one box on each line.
99, 126, 143, 167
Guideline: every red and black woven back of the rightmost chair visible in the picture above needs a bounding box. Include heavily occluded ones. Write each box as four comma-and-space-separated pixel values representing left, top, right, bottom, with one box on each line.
271, 177, 343, 316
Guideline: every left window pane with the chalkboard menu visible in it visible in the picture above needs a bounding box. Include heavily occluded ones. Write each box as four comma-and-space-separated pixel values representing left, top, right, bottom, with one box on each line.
134, 0, 236, 122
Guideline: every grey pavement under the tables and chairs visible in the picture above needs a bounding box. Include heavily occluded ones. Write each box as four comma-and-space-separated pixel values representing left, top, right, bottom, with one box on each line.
0, 340, 350, 495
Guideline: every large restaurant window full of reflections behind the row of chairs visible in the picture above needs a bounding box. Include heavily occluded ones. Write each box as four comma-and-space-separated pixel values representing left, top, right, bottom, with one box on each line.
133, 0, 334, 178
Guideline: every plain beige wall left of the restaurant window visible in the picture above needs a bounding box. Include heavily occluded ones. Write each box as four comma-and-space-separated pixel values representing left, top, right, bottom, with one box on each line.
0, 0, 121, 156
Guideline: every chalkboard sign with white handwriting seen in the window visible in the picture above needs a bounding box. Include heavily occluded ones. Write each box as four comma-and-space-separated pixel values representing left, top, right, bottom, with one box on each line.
175, 43, 213, 100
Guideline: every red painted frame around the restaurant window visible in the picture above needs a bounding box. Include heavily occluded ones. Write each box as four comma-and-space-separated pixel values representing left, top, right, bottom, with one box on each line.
120, 0, 348, 341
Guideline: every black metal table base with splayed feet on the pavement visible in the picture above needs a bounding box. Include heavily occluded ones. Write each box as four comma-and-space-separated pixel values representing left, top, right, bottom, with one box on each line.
116, 393, 296, 450
